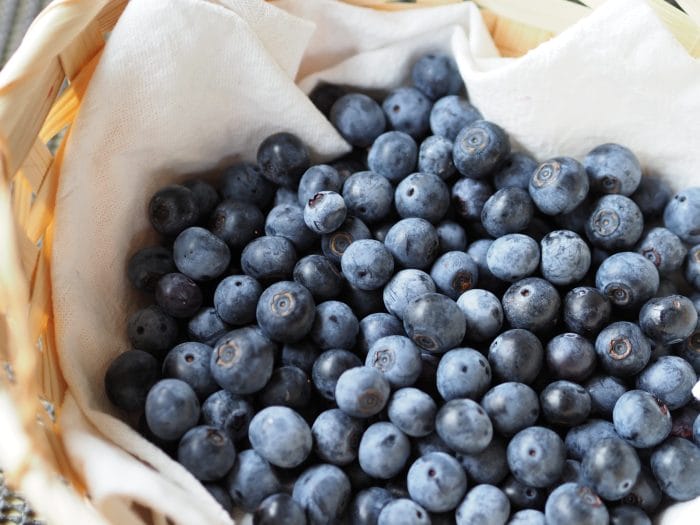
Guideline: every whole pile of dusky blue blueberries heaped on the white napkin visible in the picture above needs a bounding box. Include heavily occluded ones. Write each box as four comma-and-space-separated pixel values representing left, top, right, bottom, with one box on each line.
105, 54, 700, 525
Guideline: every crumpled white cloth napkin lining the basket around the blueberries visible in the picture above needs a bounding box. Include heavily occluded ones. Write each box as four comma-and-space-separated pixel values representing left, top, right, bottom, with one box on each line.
52, 0, 700, 525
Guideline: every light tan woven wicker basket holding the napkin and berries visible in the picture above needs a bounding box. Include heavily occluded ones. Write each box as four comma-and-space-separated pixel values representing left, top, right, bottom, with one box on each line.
0, 0, 700, 524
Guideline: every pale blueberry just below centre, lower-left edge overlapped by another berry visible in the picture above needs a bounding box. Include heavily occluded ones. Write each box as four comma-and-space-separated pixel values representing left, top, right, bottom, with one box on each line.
365, 335, 422, 388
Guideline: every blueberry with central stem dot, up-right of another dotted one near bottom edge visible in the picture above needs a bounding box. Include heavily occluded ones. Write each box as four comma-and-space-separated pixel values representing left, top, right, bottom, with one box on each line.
508, 427, 566, 488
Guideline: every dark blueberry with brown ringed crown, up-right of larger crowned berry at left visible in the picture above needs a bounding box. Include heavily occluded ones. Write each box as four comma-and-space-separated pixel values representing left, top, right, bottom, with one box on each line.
255, 281, 316, 343
